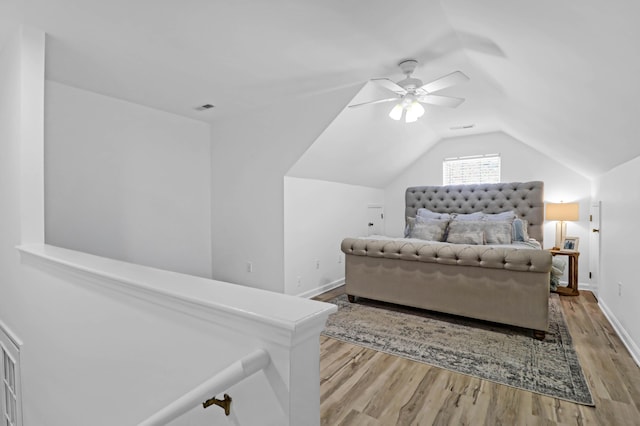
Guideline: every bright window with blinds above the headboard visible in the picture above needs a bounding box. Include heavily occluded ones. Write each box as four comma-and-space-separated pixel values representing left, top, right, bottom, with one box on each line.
442, 154, 500, 185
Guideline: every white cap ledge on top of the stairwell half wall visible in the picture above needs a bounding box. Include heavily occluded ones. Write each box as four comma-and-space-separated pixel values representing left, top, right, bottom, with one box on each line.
17, 244, 337, 347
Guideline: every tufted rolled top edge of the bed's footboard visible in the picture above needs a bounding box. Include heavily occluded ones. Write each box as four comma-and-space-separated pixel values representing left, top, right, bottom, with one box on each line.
341, 238, 551, 274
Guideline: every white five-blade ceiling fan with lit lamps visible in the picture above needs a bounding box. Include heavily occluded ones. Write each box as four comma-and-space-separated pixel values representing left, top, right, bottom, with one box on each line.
349, 59, 469, 123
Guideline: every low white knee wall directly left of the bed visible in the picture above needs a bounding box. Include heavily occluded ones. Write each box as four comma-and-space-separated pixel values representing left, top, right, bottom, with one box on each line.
284, 177, 384, 297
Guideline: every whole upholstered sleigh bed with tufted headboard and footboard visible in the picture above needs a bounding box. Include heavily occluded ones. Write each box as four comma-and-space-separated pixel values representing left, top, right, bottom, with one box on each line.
341, 181, 552, 339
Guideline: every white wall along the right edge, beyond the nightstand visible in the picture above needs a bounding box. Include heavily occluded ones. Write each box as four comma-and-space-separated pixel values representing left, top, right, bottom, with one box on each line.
594, 157, 640, 365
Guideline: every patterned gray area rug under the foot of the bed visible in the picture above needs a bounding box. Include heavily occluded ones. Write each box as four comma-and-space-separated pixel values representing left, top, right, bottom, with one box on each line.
323, 294, 594, 405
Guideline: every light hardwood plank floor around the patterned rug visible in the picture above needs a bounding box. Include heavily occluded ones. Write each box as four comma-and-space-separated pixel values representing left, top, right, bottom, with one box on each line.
317, 287, 640, 426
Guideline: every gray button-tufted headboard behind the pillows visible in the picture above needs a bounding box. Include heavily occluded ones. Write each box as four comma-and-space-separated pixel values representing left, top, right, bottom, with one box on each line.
405, 181, 544, 244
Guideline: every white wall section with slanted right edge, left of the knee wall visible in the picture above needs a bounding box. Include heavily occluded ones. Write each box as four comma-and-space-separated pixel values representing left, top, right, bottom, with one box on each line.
211, 85, 359, 293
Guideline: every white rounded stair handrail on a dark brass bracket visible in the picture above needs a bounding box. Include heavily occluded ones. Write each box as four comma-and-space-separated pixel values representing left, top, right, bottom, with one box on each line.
138, 349, 271, 426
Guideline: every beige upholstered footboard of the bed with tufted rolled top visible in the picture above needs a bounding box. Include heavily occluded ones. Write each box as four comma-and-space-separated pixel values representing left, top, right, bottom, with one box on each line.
341, 238, 551, 338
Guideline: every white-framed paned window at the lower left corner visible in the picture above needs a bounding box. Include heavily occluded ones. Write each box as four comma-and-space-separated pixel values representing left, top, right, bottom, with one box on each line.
0, 322, 22, 426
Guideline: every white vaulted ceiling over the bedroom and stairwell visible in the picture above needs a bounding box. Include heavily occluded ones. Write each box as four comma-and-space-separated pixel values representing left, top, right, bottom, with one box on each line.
8, 0, 640, 185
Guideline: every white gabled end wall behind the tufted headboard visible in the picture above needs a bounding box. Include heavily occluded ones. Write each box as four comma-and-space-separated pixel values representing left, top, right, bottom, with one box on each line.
385, 132, 591, 288
